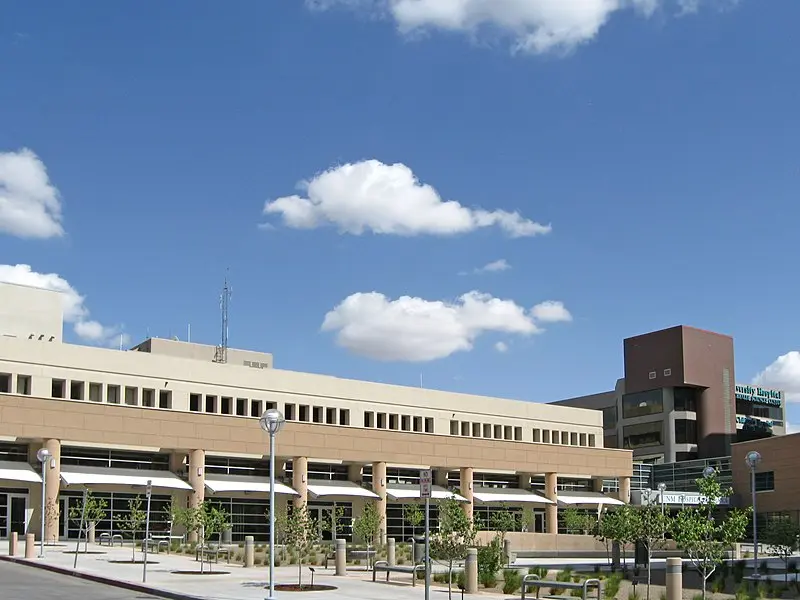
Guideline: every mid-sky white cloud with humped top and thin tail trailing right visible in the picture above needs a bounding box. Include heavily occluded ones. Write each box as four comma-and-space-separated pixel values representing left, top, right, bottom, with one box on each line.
264, 160, 551, 237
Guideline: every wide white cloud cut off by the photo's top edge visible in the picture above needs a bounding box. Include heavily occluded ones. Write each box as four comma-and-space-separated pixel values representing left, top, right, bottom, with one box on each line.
306, 0, 738, 54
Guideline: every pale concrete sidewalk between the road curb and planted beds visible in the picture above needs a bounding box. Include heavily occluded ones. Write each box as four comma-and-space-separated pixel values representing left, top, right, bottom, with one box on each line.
0, 542, 438, 600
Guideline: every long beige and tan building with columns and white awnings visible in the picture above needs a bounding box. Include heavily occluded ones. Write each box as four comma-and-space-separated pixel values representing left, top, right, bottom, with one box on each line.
0, 284, 632, 549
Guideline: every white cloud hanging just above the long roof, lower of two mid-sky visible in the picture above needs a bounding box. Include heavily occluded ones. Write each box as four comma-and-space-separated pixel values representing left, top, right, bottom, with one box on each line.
322, 291, 566, 362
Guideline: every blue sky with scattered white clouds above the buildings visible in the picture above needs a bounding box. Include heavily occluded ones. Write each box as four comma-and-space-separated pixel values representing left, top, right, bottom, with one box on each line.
0, 0, 800, 422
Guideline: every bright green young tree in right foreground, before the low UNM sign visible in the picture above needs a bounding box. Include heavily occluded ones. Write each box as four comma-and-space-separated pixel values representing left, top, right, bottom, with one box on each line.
672, 474, 752, 600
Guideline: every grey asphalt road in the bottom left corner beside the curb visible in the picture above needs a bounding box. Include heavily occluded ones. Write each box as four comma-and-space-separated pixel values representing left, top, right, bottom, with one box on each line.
0, 562, 157, 600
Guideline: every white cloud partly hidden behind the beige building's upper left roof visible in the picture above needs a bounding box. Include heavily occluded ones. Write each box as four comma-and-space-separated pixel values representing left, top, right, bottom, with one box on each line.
0, 265, 130, 346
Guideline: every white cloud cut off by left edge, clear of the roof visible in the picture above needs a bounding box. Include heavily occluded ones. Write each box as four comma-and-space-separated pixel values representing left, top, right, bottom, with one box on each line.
0, 148, 64, 239
